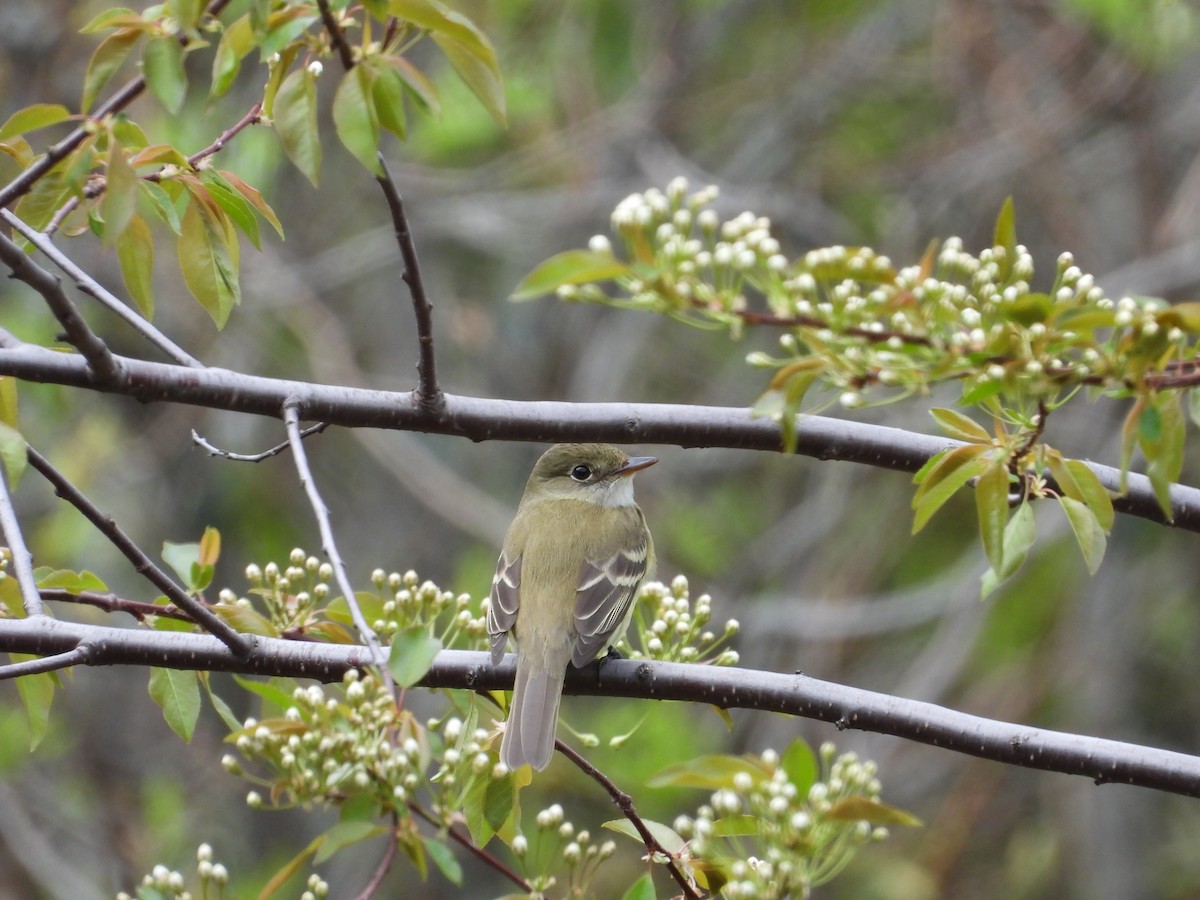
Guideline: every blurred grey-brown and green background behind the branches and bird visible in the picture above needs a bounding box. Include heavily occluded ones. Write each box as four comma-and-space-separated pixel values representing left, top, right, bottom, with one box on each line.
0, 0, 1200, 900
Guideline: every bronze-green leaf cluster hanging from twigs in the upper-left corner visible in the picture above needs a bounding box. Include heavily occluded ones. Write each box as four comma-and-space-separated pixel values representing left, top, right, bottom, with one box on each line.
0, 0, 505, 328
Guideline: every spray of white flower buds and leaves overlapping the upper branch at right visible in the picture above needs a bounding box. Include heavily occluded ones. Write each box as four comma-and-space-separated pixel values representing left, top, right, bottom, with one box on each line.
514, 179, 1200, 595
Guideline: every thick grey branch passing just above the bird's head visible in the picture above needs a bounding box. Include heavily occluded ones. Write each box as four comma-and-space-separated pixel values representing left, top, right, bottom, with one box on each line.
0, 338, 1200, 532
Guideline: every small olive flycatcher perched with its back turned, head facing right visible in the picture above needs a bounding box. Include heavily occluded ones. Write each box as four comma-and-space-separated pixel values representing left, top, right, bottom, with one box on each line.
487, 444, 658, 769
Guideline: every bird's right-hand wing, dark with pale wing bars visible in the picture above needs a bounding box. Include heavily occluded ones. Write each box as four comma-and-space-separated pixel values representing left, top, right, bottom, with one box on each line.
571, 534, 652, 668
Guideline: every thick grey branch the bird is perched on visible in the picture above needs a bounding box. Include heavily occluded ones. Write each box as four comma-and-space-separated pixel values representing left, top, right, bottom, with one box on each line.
0, 619, 1200, 797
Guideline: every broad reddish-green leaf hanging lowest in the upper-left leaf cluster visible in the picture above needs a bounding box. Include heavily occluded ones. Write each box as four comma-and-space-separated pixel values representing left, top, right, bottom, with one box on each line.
176, 197, 241, 328
